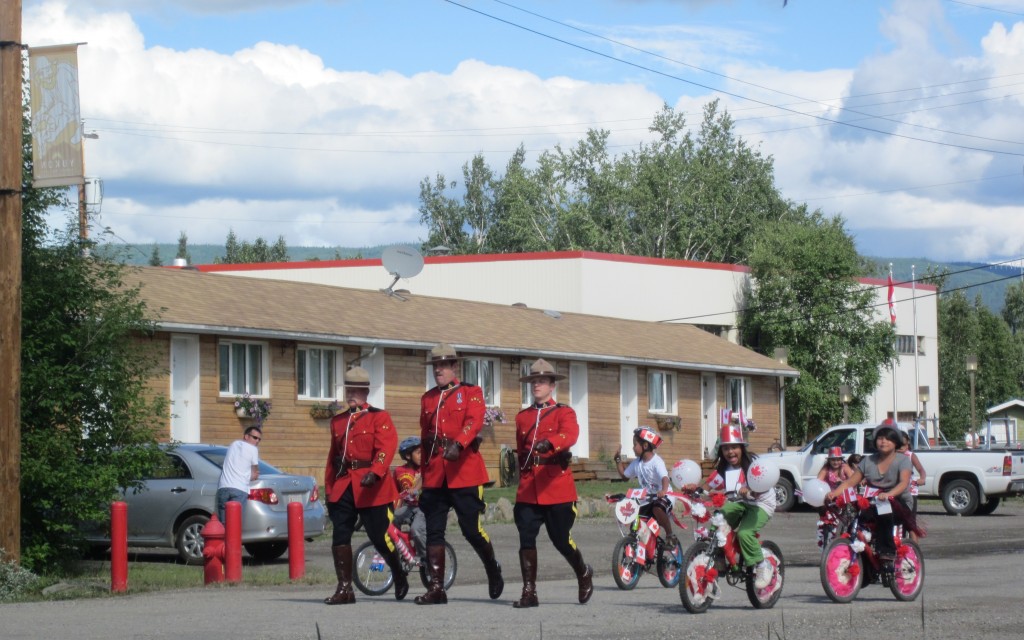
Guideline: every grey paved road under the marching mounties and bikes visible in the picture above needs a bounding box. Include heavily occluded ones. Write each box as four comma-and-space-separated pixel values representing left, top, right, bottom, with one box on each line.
6, 504, 1024, 640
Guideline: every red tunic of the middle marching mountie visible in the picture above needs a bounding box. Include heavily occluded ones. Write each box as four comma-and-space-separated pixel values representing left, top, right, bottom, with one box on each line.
420, 381, 489, 488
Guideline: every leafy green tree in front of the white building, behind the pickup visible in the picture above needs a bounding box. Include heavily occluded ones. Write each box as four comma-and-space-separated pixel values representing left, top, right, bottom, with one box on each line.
739, 213, 896, 441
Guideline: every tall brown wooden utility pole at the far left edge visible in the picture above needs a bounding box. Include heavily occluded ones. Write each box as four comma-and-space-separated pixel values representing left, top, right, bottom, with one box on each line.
0, 0, 22, 561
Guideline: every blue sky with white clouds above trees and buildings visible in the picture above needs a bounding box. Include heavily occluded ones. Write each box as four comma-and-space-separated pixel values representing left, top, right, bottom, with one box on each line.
23, 0, 1024, 262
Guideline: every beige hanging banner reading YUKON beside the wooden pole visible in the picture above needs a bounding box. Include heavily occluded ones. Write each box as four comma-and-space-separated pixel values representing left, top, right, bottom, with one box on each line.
29, 44, 85, 186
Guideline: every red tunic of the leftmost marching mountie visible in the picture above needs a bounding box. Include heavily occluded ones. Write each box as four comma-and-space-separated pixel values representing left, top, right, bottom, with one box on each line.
324, 404, 398, 509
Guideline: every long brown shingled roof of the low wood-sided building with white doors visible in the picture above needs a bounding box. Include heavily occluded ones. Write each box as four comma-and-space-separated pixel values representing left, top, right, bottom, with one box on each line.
126, 267, 798, 377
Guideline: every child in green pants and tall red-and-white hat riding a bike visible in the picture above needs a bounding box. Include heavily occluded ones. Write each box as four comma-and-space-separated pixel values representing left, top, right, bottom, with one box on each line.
705, 420, 775, 589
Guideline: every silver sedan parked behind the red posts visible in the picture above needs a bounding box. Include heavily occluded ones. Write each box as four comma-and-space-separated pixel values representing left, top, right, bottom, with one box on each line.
86, 444, 327, 564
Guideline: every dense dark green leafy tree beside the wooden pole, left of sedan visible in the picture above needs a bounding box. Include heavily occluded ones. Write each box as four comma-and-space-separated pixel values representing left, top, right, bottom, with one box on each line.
20, 93, 166, 571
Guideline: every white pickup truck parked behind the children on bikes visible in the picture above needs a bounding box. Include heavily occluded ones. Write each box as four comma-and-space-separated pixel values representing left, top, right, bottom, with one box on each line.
759, 424, 1024, 515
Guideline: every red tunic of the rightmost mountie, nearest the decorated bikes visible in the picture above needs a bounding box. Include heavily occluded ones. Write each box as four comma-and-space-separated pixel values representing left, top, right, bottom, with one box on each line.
515, 400, 580, 505
